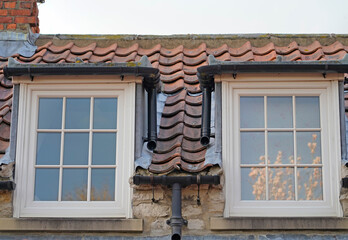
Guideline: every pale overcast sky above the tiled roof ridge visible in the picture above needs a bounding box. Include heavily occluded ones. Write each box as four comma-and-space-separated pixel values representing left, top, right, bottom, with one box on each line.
39, 0, 348, 35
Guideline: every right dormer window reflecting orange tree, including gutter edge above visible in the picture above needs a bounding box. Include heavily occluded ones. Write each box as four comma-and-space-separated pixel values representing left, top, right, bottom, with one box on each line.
198, 55, 347, 217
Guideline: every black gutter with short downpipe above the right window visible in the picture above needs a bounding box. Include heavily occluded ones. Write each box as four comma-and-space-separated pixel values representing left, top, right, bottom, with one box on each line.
197, 54, 348, 146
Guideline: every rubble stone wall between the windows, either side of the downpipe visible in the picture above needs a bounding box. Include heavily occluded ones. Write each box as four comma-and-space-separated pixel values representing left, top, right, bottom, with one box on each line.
132, 179, 225, 236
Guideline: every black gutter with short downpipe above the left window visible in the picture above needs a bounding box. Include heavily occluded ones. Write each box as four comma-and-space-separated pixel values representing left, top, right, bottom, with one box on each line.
4, 56, 160, 150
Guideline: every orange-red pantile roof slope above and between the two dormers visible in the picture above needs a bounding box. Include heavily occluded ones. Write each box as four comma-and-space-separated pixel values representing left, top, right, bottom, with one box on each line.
0, 36, 348, 173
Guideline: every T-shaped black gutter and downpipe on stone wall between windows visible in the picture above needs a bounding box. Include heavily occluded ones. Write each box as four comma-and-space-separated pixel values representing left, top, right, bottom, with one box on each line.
133, 175, 220, 240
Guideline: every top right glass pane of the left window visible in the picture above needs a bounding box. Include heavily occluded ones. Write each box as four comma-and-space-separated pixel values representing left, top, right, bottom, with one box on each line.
93, 98, 117, 129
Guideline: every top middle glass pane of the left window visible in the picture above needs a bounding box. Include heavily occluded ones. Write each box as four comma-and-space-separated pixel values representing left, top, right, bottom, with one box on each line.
65, 98, 91, 129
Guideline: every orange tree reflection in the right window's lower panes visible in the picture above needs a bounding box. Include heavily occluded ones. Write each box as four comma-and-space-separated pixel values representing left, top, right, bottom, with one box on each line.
249, 134, 323, 200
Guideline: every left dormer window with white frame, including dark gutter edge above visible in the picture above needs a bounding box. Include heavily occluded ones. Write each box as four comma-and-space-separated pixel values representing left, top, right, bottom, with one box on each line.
5, 58, 158, 218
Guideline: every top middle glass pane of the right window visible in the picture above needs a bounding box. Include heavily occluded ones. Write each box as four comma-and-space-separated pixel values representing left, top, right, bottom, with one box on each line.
267, 97, 293, 128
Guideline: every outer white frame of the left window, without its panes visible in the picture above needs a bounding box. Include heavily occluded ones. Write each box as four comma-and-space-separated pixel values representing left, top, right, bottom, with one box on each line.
13, 77, 136, 218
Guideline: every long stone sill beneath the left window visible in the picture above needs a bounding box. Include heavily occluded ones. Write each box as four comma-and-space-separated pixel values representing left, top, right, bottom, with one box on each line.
0, 218, 143, 232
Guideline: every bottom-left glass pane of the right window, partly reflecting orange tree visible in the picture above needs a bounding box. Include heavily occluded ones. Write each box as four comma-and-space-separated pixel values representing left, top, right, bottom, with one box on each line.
241, 167, 266, 200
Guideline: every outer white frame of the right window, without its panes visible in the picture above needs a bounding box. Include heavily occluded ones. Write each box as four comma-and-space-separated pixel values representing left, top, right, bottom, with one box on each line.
221, 75, 342, 217
